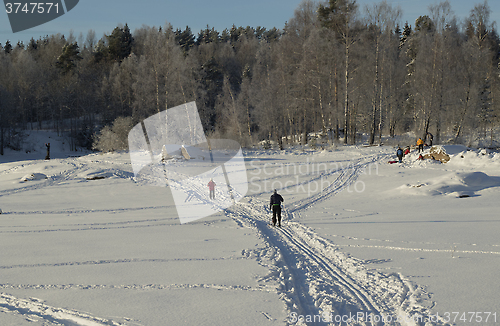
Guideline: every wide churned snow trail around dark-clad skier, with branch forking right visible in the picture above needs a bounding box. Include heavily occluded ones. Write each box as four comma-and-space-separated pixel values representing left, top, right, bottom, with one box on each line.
226, 155, 444, 326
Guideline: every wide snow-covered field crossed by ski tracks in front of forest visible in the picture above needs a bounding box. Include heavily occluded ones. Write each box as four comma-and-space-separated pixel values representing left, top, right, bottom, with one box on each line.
0, 132, 500, 326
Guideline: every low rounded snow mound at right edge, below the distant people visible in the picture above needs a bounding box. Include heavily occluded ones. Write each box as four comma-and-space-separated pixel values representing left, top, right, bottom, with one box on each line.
399, 172, 500, 198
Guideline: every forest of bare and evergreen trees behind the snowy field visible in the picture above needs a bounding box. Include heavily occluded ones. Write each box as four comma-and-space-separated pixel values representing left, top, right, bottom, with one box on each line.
0, 0, 500, 154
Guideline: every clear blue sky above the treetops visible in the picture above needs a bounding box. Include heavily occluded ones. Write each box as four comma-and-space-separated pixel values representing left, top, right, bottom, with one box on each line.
0, 0, 500, 45
